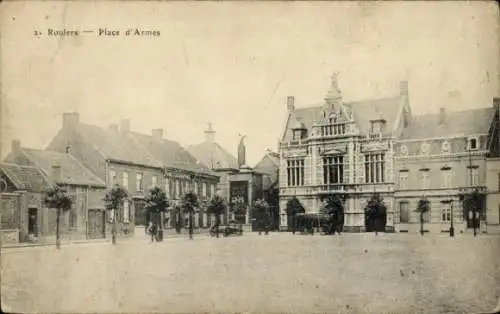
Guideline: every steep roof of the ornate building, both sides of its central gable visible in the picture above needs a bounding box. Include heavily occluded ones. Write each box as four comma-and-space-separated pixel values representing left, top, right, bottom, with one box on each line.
283, 96, 403, 141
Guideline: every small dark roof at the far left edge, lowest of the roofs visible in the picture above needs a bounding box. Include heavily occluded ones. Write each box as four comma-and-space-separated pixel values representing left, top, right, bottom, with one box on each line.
0, 163, 50, 192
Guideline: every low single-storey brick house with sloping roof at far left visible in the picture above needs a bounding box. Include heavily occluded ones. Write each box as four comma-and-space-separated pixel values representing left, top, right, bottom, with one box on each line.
0, 141, 105, 242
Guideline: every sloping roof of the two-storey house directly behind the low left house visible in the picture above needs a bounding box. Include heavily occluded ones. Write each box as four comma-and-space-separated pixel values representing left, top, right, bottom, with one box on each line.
77, 123, 162, 168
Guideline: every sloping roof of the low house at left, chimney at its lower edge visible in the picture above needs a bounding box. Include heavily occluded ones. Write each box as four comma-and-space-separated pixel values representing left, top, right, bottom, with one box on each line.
21, 148, 106, 187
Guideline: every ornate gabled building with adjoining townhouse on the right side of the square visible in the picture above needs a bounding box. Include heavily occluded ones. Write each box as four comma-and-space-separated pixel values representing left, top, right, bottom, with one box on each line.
279, 76, 500, 232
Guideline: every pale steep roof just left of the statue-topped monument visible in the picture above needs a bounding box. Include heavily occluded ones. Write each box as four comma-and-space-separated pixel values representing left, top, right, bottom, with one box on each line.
187, 141, 238, 169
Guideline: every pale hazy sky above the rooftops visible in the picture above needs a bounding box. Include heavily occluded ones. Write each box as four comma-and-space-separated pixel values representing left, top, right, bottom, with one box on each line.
1, 1, 500, 165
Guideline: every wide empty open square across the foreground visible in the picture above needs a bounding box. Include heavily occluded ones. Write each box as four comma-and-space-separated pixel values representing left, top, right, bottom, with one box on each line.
1, 233, 500, 313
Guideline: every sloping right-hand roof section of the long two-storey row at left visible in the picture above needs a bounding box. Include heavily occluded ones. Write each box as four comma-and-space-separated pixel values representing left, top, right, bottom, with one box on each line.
130, 132, 210, 173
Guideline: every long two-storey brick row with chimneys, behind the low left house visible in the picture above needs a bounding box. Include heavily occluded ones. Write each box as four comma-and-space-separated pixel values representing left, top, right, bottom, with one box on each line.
47, 113, 217, 234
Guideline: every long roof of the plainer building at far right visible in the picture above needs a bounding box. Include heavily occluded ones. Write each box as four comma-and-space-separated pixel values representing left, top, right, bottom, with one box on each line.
402, 108, 494, 139
